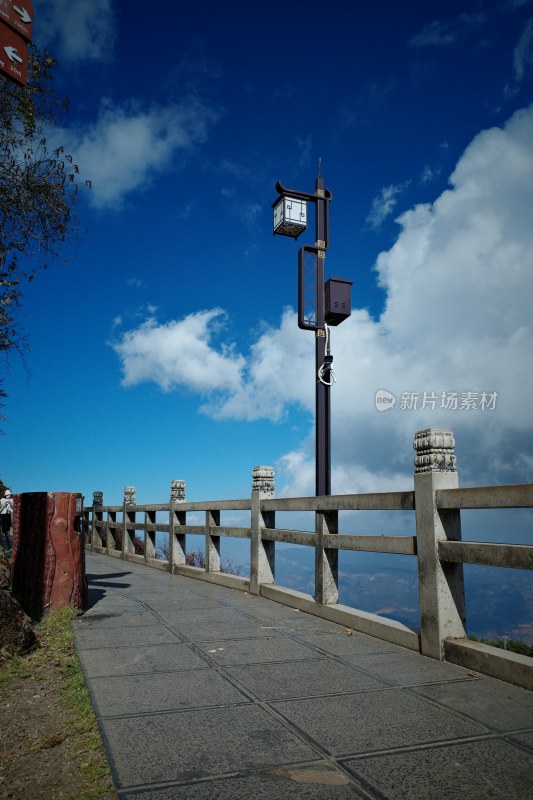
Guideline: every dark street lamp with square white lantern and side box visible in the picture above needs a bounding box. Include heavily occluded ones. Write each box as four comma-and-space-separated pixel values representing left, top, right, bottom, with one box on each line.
272, 168, 352, 496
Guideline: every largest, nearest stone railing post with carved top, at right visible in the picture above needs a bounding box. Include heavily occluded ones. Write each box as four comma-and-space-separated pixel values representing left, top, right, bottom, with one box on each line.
413, 428, 466, 661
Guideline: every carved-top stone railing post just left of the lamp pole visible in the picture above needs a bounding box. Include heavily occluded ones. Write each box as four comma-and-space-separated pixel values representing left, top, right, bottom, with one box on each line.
250, 467, 276, 594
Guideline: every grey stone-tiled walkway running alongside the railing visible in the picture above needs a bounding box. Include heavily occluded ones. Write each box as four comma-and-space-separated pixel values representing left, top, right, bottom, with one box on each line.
74, 554, 533, 800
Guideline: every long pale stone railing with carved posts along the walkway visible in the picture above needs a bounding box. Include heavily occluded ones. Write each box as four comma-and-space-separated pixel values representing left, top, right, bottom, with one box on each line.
85, 429, 533, 688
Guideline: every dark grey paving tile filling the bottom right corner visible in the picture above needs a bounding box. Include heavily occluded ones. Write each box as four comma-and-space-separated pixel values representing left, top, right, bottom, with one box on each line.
345, 739, 533, 800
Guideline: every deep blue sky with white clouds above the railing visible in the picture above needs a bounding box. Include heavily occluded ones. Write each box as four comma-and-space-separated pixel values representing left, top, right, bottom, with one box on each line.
0, 0, 533, 524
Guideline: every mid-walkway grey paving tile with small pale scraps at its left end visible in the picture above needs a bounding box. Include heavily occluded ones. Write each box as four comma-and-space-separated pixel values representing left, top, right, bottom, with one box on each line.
193, 636, 320, 669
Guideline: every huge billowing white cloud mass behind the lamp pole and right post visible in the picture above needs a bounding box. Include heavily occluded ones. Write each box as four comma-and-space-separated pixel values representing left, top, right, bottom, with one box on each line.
115, 106, 533, 495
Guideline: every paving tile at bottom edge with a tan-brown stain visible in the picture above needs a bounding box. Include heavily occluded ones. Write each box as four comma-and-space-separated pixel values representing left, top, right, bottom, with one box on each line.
119, 762, 357, 800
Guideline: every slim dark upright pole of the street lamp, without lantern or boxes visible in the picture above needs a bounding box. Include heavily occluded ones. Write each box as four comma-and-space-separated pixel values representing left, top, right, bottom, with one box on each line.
315, 175, 331, 496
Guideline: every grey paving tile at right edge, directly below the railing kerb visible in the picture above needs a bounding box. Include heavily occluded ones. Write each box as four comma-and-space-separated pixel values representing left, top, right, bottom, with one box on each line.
413, 675, 533, 730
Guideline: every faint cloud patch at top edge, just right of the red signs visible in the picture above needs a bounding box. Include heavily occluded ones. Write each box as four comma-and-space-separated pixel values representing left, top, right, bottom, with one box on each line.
37, 0, 116, 63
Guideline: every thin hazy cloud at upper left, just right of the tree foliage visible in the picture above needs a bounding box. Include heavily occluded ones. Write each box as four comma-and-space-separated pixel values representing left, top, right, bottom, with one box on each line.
57, 100, 216, 209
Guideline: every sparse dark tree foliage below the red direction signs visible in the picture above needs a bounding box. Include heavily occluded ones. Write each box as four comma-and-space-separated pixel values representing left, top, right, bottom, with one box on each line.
0, 45, 89, 354
